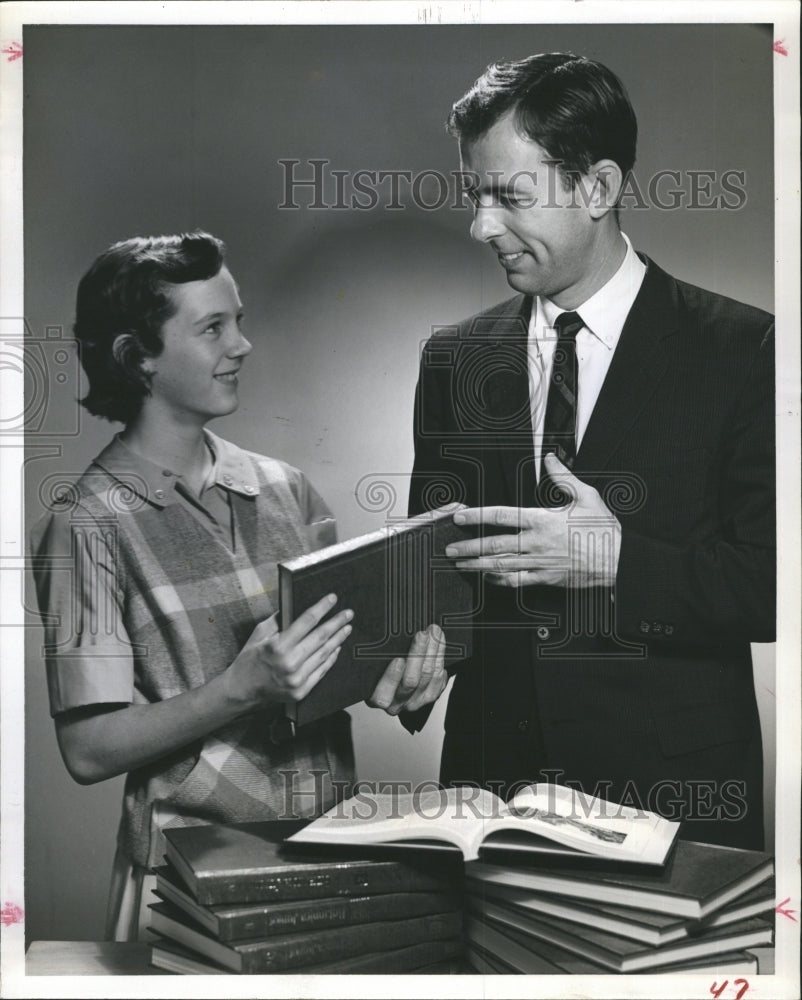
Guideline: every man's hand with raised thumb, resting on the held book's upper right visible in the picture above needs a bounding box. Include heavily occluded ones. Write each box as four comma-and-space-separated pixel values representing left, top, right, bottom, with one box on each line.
446, 454, 621, 588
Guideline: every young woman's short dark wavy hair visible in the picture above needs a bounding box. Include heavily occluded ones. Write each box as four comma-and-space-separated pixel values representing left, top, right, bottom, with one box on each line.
73, 232, 225, 423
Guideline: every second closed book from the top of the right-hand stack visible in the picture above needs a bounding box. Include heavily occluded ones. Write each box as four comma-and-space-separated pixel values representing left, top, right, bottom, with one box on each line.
462, 878, 774, 947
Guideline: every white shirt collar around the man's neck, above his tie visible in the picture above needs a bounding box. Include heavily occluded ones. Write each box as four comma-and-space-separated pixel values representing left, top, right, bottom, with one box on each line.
535, 233, 646, 351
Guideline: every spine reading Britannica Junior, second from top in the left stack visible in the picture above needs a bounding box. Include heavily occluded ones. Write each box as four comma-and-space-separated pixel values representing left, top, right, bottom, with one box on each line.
217, 892, 459, 941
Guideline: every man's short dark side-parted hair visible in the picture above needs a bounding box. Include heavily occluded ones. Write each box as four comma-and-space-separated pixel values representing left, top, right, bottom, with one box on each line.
446, 52, 638, 186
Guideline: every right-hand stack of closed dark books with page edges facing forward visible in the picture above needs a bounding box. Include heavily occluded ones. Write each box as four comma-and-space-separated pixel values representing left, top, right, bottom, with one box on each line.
465, 840, 775, 975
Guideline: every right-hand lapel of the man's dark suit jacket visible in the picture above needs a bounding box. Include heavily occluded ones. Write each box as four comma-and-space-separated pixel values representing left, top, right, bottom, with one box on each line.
574, 258, 678, 476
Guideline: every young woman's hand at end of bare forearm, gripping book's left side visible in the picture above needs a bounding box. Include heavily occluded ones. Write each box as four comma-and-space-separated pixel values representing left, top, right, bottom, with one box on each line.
227, 594, 353, 710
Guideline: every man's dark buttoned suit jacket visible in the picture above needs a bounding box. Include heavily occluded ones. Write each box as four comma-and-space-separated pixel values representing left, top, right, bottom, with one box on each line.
410, 258, 775, 848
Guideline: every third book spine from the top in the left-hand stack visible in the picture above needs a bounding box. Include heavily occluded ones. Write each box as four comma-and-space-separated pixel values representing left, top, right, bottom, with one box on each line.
237, 913, 462, 974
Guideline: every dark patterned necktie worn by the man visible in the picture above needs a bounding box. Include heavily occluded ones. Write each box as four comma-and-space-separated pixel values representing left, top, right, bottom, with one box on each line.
538, 312, 585, 507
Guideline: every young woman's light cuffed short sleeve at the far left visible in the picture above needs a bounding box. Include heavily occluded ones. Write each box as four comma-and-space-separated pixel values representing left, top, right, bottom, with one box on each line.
31, 512, 134, 715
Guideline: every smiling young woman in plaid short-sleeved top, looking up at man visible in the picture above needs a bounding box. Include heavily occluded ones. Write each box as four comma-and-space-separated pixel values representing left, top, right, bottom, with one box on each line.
33, 233, 447, 940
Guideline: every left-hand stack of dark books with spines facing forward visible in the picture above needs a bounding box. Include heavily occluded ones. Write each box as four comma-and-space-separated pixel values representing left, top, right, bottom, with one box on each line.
145, 821, 463, 974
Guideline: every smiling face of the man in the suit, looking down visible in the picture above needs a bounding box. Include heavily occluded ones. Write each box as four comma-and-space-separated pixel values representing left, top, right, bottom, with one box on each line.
461, 114, 604, 308
